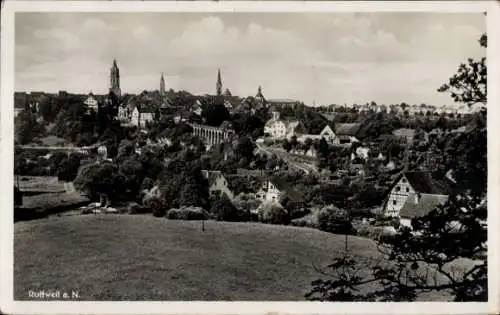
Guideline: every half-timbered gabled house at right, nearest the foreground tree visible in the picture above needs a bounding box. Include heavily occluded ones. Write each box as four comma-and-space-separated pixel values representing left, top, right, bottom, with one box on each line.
385, 171, 453, 226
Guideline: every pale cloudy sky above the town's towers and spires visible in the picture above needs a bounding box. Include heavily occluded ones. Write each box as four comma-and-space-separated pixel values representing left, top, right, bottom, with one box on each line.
15, 12, 486, 105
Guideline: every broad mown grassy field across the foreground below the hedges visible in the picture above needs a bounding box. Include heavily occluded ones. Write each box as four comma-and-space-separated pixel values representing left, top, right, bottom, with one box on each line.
14, 215, 377, 301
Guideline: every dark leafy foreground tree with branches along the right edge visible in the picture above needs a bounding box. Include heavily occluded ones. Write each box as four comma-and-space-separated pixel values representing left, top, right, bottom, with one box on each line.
306, 32, 488, 301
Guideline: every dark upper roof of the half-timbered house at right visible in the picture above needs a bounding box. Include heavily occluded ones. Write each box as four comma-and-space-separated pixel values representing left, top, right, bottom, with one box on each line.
403, 171, 452, 195
